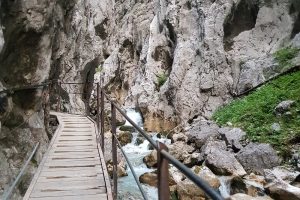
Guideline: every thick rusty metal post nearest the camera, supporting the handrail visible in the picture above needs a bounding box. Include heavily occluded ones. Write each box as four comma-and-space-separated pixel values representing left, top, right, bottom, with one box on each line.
157, 142, 170, 200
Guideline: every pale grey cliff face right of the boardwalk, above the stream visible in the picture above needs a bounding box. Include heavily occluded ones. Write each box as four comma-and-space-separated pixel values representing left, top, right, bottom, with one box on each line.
95, 0, 300, 131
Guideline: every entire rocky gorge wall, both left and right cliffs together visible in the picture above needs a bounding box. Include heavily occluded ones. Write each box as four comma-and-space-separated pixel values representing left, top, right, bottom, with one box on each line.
0, 0, 300, 198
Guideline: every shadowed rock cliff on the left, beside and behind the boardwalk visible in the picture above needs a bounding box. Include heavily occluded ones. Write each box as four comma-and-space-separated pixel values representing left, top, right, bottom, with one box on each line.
0, 0, 108, 198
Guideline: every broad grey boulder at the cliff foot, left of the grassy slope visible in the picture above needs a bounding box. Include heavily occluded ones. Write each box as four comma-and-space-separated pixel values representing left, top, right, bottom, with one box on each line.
185, 120, 219, 148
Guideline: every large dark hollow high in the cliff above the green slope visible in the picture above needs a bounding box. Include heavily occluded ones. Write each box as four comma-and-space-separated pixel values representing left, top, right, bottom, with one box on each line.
223, 0, 259, 51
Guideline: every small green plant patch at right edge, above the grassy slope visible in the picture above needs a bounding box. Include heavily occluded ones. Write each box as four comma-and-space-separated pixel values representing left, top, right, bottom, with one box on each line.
274, 47, 300, 69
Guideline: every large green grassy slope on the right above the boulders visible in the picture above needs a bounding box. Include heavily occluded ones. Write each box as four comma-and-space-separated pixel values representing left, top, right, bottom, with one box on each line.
213, 71, 300, 157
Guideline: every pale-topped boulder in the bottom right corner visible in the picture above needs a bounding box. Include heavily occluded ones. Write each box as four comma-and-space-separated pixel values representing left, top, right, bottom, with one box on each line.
265, 179, 300, 200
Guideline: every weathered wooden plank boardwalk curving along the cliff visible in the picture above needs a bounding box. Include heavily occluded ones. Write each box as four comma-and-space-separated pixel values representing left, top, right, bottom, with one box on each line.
24, 112, 112, 200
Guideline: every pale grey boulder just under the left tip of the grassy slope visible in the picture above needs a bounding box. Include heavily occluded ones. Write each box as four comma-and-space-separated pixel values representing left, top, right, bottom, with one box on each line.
218, 127, 246, 151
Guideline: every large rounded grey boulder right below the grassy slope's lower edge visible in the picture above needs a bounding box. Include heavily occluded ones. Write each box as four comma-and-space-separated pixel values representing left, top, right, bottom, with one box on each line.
237, 143, 281, 174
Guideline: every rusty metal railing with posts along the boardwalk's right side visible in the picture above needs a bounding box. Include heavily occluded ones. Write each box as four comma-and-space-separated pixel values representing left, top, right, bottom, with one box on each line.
97, 83, 223, 200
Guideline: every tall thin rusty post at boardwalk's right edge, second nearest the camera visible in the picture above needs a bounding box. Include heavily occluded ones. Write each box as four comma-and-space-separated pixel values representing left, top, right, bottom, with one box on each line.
111, 103, 118, 199
